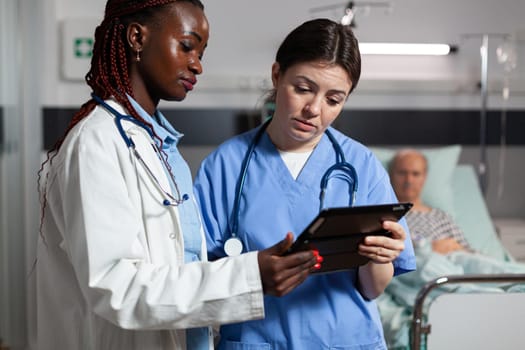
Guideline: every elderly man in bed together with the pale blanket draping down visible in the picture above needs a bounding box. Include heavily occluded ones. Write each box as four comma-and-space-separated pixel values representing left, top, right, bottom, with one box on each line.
378, 149, 525, 350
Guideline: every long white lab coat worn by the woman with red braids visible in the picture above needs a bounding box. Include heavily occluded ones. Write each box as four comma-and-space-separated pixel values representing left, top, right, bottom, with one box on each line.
31, 101, 264, 350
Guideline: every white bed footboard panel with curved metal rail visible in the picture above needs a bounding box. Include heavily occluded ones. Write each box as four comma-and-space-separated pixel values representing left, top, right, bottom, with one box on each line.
411, 274, 525, 350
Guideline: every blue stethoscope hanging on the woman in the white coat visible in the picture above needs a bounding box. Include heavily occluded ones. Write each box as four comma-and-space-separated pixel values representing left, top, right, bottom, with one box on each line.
91, 94, 189, 206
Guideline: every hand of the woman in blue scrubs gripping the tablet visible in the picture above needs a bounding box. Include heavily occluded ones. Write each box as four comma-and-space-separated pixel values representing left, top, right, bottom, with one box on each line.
359, 221, 406, 264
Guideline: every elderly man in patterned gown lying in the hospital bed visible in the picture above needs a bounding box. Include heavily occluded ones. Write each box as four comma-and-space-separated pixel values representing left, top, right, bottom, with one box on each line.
388, 149, 525, 276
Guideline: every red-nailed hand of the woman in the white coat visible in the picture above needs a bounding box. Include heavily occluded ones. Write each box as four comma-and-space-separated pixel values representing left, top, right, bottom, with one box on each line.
258, 233, 322, 296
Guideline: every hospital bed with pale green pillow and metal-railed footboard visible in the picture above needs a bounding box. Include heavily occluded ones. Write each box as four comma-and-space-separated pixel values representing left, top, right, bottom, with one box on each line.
372, 146, 525, 350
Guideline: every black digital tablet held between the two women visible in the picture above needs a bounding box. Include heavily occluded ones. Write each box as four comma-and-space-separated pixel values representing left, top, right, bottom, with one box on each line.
288, 203, 412, 273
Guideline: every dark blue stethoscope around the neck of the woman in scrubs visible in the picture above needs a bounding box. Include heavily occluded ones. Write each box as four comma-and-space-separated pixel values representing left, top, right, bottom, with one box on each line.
224, 119, 357, 256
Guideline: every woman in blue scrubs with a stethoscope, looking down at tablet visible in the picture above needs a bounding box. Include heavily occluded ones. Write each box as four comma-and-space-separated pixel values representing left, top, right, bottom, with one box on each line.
195, 19, 416, 350
